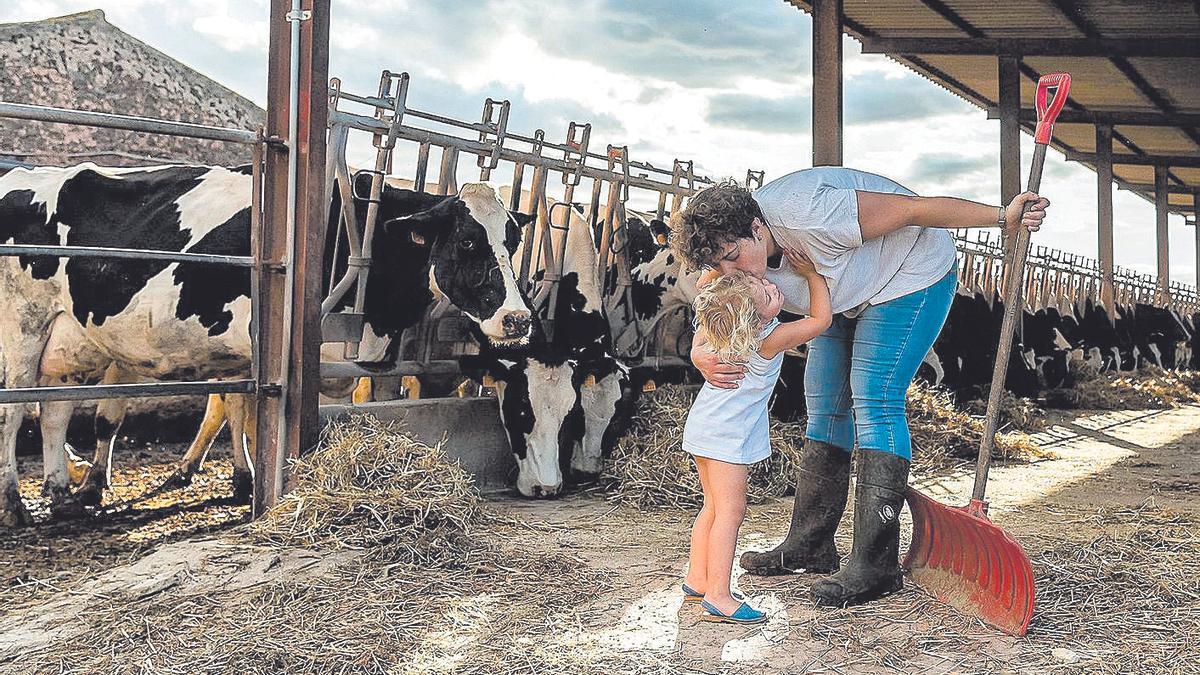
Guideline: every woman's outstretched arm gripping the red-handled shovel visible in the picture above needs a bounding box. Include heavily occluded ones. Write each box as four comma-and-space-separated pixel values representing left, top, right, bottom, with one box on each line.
854, 190, 1050, 240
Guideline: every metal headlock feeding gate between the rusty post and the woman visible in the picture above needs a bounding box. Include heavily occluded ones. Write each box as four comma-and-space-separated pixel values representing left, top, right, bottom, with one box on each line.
320, 71, 763, 377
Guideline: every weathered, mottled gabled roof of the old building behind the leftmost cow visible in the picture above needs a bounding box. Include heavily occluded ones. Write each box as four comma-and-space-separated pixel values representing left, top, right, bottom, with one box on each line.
0, 10, 265, 171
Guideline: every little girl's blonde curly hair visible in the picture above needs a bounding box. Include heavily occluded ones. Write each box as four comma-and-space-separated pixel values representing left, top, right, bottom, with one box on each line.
692, 271, 762, 363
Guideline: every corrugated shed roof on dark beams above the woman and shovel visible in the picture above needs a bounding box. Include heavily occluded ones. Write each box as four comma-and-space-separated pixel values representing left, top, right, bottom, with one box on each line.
786, 0, 1200, 213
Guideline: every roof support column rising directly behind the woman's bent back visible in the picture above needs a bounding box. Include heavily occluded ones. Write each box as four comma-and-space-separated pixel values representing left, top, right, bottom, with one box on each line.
812, 0, 842, 167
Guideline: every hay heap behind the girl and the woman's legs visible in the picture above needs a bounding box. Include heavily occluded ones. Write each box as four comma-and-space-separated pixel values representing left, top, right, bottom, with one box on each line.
600, 384, 1043, 508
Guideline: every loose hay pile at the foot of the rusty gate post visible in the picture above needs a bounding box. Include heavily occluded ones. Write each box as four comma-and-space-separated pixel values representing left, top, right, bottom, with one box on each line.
251, 414, 485, 565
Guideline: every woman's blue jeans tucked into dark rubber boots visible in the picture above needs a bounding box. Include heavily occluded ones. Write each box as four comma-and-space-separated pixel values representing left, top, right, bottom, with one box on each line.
804, 268, 958, 459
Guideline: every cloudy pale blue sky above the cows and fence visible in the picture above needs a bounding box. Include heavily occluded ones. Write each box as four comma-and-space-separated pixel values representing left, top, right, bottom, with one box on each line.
0, 0, 1195, 283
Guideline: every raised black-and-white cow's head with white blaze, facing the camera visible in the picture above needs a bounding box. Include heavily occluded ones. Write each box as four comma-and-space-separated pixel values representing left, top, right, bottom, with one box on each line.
383, 183, 532, 345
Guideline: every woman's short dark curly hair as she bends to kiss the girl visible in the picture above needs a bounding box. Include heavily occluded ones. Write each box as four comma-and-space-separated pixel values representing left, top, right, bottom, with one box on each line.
671, 180, 766, 270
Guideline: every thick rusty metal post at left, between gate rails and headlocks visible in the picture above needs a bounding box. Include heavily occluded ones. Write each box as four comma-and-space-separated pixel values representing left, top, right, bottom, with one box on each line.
253, 0, 329, 516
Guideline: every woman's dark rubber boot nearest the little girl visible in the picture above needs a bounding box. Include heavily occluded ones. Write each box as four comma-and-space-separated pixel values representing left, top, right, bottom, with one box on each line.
742, 441, 850, 577
